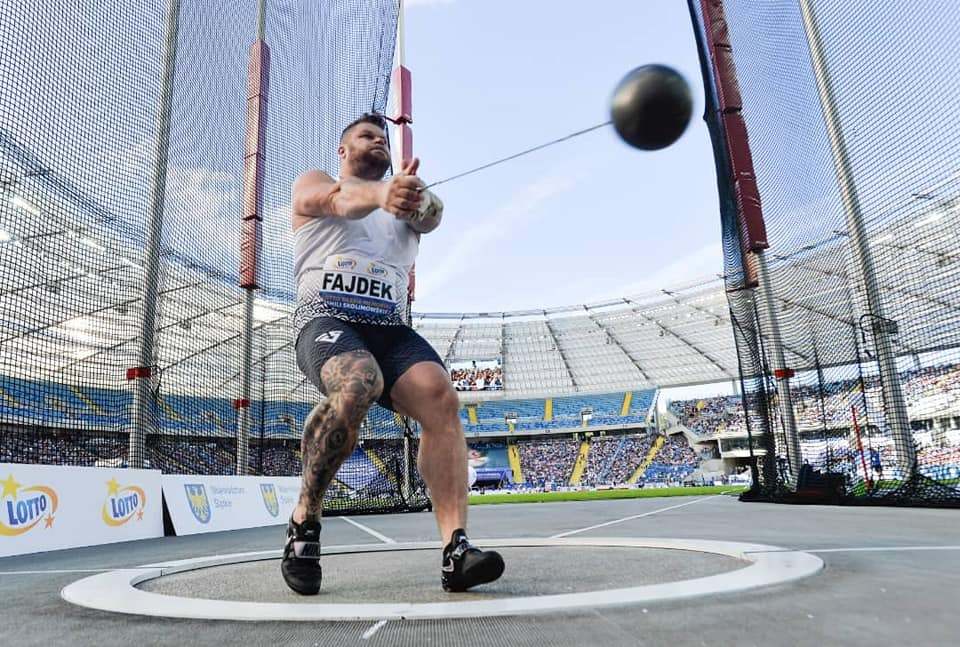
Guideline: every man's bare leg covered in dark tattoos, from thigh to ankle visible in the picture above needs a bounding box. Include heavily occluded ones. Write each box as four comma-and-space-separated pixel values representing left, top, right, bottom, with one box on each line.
293, 350, 383, 523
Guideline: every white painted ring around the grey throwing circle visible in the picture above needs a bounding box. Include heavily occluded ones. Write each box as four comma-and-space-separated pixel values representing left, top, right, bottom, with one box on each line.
60, 537, 823, 622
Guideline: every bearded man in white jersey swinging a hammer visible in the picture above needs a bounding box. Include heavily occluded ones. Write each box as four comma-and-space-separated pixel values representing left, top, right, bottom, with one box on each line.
281, 115, 504, 595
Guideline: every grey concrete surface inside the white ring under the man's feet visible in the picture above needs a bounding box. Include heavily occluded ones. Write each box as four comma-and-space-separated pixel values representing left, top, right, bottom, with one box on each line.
140, 542, 747, 604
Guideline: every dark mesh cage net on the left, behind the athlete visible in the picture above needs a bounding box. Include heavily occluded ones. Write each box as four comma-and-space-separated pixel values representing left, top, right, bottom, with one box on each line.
0, 0, 422, 510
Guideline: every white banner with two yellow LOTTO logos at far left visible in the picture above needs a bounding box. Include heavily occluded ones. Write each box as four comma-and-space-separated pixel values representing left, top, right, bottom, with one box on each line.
0, 463, 163, 557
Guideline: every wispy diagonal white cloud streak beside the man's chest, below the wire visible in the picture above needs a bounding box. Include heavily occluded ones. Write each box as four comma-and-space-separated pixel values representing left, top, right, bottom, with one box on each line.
417, 175, 574, 299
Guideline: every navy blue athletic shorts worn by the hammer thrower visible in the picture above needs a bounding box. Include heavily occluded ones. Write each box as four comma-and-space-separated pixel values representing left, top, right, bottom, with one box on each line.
297, 317, 443, 411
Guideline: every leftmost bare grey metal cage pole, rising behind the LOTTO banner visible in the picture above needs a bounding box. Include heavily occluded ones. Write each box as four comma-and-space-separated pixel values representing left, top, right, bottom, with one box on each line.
127, 0, 180, 468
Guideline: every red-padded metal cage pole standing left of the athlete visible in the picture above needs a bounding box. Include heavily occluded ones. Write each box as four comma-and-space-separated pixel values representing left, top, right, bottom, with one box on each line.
234, 0, 270, 475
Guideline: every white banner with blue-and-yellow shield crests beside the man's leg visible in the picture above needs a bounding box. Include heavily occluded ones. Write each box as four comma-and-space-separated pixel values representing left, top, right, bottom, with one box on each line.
161, 474, 300, 535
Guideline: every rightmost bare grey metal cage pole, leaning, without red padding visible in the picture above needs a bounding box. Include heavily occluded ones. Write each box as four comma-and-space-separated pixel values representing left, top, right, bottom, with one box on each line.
799, 0, 916, 470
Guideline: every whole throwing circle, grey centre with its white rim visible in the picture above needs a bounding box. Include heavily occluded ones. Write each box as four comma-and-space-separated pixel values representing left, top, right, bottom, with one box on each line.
61, 537, 823, 621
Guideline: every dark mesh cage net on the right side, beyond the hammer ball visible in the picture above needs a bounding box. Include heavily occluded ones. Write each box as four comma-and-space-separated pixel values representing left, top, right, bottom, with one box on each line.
690, 0, 960, 504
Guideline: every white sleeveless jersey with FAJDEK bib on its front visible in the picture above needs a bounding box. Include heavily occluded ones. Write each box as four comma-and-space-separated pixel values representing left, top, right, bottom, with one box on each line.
293, 209, 419, 331
